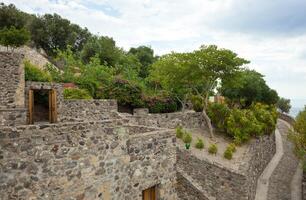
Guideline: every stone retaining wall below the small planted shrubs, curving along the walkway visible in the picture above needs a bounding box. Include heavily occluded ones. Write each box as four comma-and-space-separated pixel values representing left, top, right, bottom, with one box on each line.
177, 135, 275, 200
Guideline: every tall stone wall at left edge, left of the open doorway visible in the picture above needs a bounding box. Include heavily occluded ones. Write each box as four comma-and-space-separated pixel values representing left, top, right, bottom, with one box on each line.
0, 52, 24, 109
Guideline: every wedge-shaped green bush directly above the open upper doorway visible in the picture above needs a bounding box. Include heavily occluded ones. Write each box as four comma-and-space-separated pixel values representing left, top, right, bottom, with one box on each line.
24, 61, 52, 82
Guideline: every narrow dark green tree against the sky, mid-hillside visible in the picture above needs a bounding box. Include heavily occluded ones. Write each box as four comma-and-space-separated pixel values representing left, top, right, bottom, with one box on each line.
129, 46, 156, 78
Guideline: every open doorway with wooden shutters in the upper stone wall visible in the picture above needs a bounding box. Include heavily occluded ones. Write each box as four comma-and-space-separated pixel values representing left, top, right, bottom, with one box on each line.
29, 89, 57, 124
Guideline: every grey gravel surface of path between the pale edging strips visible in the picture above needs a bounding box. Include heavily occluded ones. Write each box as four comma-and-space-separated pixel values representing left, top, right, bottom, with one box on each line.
267, 120, 299, 200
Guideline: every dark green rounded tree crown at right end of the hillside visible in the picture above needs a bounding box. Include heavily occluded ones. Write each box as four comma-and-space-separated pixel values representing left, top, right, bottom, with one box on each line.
220, 70, 279, 108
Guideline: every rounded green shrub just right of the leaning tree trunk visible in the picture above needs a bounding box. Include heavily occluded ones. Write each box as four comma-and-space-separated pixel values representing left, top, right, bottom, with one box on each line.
207, 103, 231, 132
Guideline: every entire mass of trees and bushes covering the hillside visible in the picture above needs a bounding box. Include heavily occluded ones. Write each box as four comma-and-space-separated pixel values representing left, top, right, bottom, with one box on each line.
0, 3, 279, 144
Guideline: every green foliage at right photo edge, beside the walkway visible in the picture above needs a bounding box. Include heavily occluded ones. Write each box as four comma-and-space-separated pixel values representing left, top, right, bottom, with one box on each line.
289, 106, 306, 172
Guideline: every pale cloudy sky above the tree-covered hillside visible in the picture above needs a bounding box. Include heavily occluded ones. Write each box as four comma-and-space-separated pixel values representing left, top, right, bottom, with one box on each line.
3, 0, 306, 111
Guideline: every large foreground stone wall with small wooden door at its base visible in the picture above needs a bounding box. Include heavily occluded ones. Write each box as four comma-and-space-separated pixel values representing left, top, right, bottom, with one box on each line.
0, 120, 176, 200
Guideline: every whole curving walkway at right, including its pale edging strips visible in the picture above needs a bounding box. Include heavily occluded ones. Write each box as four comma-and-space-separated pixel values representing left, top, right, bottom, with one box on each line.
256, 120, 302, 200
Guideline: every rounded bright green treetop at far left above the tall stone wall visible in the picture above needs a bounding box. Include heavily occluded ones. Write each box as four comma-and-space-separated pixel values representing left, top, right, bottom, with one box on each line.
0, 26, 30, 48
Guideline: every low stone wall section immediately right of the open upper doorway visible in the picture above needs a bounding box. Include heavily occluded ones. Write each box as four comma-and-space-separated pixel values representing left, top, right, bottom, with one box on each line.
59, 99, 119, 121
